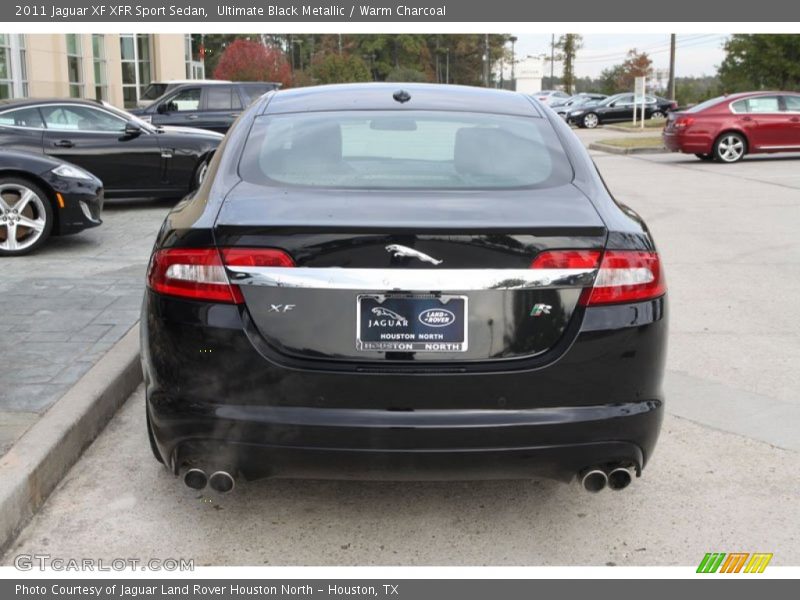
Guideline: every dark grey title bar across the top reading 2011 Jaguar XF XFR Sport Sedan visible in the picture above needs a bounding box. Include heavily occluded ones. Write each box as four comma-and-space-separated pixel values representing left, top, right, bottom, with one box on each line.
0, 0, 800, 23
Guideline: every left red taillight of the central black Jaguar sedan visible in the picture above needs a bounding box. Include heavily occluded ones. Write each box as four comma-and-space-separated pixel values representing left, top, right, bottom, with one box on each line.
147, 248, 294, 304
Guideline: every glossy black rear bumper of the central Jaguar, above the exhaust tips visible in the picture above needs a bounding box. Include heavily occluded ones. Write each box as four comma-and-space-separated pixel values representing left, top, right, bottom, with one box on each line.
142, 292, 666, 480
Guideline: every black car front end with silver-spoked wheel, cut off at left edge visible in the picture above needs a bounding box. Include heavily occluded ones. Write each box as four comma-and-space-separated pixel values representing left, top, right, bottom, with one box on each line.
0, 149, 103, 256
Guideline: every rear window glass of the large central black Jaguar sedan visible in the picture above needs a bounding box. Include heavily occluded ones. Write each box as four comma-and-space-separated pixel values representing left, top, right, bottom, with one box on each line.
239, 111, 573, 189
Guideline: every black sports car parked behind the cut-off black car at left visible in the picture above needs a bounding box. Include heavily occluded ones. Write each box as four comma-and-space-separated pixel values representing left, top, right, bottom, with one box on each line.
0, 99, 223, 198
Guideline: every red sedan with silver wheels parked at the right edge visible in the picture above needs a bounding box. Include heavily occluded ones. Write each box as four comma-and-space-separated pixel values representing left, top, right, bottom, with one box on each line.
662, 92, 800, 163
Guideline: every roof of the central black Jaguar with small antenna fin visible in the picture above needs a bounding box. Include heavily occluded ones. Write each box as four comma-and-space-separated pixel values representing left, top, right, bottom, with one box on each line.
262, 83, 542, 117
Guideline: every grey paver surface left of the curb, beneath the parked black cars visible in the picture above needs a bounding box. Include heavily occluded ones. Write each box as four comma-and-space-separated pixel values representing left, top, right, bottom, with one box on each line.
0, 200, 174, 455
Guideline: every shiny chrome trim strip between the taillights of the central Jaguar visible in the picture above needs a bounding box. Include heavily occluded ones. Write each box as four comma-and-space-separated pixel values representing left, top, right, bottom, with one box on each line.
226, 266, 597, 292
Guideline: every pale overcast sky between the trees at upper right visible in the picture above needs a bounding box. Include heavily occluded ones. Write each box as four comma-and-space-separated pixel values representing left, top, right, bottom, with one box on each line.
514, 33, 727, 77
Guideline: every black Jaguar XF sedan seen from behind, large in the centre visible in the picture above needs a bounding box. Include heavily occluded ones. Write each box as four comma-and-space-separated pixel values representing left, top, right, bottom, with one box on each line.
141, 84, 667, 491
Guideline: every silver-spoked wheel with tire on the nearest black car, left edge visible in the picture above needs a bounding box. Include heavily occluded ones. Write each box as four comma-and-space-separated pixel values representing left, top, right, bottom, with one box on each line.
0, 177, 54, 256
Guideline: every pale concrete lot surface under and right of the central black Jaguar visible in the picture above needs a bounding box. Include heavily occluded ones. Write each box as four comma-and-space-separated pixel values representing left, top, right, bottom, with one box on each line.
2, 137, 800, 565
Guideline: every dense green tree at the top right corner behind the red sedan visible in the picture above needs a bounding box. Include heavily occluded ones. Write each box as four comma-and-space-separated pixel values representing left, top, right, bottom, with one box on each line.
719, 34, 800, 93
